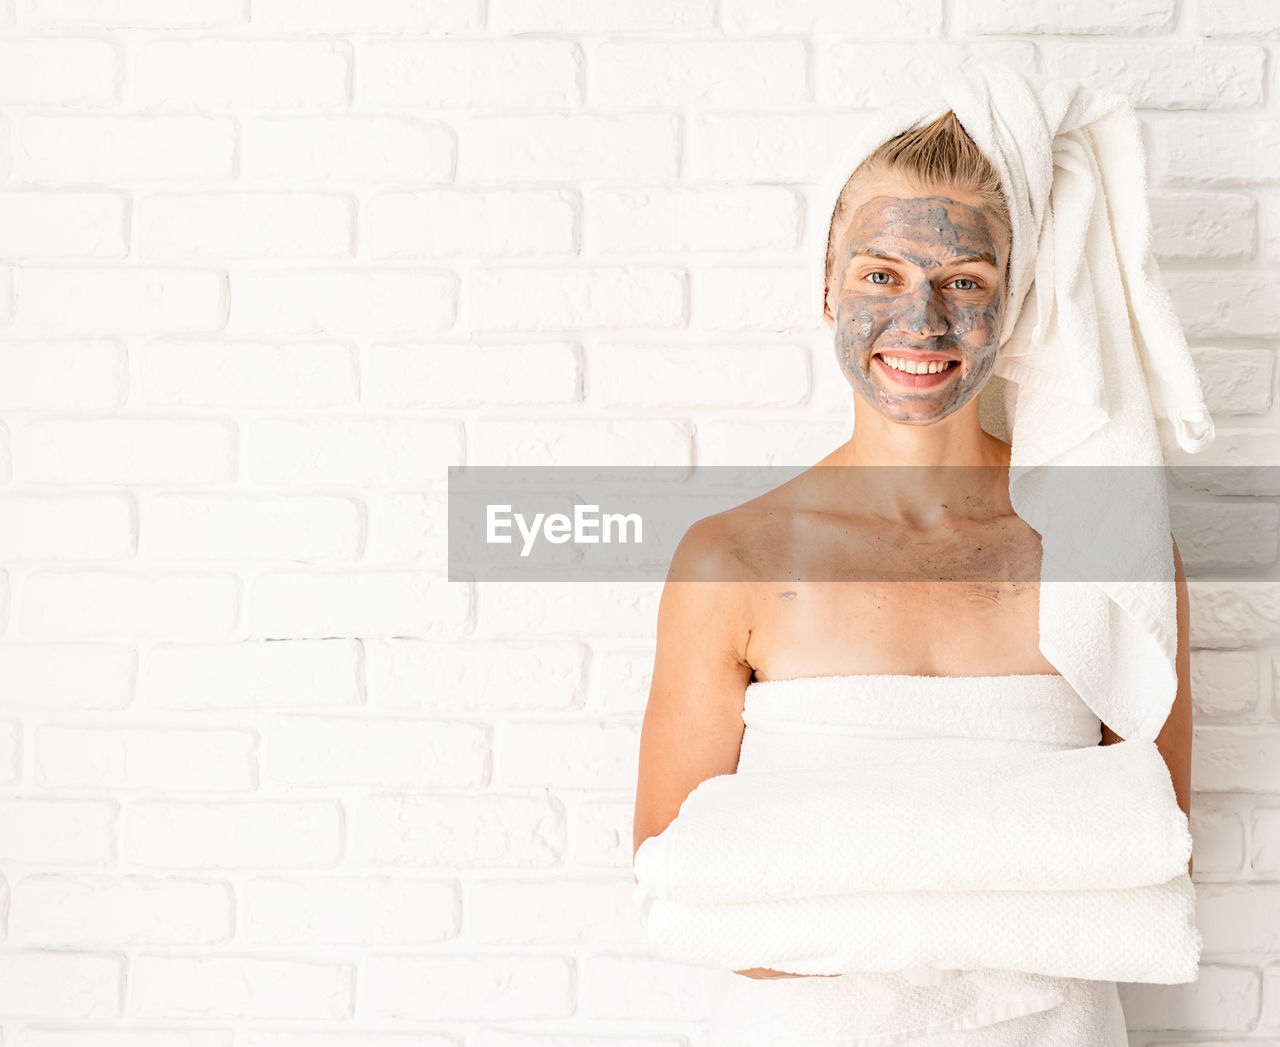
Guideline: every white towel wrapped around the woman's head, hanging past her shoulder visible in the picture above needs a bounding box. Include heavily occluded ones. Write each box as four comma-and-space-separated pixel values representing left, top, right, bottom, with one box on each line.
809, 63, 1213, 741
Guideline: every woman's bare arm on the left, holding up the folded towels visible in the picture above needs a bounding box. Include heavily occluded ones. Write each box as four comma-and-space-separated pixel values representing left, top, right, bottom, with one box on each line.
632, 517, 834, 978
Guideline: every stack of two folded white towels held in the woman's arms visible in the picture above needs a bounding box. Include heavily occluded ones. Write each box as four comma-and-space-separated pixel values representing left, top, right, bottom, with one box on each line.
635, 740, 1202, 984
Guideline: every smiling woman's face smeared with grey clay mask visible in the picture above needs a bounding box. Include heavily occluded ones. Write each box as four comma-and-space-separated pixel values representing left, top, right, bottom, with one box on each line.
827, 180, 1009, 425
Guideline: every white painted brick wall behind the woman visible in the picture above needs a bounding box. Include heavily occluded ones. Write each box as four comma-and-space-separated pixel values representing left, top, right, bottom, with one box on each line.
0, 0, 1280, 1047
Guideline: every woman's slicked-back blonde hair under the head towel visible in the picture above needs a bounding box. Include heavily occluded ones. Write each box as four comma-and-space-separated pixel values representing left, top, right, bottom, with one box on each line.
823, 109, 1012, 297
